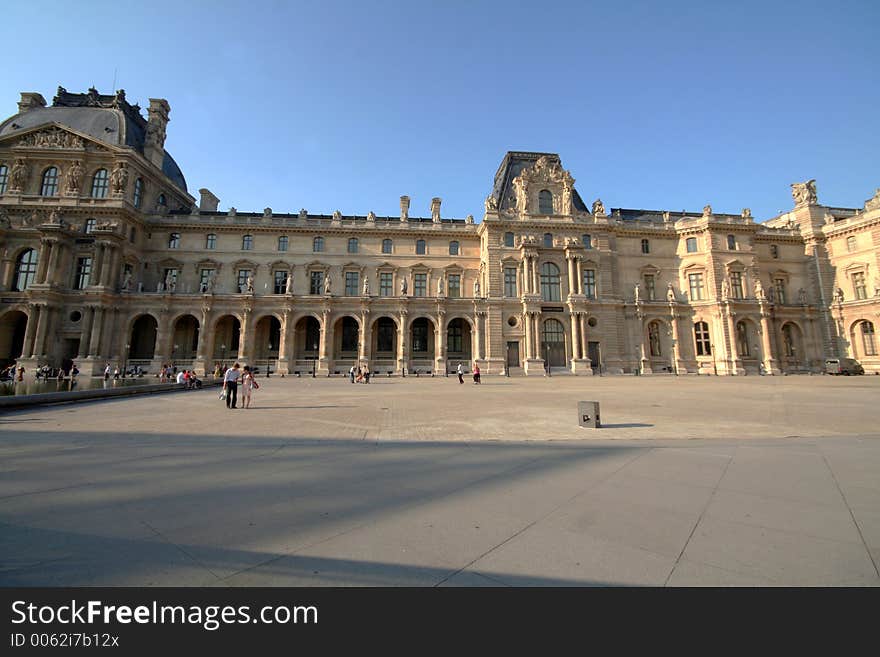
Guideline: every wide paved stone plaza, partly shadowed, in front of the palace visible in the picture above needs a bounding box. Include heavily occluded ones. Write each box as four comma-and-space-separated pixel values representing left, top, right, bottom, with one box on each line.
0, 376, 880, 586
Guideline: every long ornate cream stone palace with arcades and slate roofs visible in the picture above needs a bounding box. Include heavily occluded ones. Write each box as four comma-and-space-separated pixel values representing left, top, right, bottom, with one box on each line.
0, 87, 880, 375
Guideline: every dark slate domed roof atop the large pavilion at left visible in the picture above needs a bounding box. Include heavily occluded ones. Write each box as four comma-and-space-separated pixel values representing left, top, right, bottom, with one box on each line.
0, 87, 187, 192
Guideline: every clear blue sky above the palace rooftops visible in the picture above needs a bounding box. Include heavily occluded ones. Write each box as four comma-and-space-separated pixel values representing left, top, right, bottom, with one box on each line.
0, 0, 880, 220
